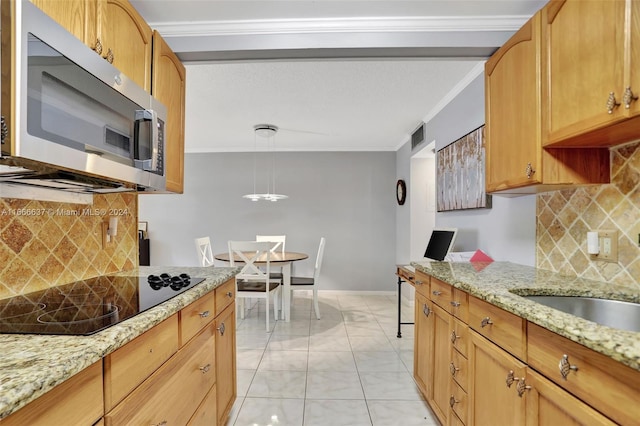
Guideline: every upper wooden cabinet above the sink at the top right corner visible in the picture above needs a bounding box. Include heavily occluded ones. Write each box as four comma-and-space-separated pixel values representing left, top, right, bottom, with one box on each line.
542, 0, 640, 147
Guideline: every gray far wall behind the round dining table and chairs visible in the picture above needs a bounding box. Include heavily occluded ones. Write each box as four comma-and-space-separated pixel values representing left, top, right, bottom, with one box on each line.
139, 152, 396, 291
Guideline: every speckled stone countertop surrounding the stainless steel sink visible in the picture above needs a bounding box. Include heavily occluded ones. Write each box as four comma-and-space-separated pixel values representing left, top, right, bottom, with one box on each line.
411, 260, 640, 370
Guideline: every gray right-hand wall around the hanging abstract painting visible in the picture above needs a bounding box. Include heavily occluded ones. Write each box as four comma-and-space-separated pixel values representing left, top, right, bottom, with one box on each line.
426, 73, 536, 266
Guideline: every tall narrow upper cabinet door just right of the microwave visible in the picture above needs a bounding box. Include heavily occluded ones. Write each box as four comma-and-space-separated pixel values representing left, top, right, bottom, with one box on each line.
151, 31, 186, 194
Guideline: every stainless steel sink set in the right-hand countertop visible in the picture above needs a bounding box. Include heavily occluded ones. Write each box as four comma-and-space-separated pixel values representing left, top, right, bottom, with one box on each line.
523, 296, 640, 332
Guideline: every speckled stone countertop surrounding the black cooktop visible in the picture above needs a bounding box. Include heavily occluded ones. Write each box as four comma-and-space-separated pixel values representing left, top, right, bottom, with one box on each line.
0, 266, 239, 419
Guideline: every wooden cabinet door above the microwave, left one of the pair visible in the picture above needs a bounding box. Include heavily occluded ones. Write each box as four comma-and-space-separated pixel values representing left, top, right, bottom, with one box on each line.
31, 0, 96, 48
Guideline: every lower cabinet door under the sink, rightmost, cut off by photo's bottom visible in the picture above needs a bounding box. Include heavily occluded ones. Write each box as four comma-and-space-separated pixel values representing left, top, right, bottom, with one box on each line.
526, 369, 615, 426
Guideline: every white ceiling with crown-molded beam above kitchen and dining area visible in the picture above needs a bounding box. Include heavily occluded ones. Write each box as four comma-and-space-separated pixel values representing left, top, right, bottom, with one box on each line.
131, 0, 546, 152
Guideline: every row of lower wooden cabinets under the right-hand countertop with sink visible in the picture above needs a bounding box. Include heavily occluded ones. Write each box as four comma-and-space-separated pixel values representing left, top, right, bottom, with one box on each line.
414, 277, 640, 426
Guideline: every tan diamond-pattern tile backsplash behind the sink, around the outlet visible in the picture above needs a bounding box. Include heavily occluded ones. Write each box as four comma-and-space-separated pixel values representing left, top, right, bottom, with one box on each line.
536, 142, 640, 290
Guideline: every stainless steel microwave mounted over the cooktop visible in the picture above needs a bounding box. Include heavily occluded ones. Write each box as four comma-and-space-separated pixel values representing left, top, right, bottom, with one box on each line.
2, 0, 167, 190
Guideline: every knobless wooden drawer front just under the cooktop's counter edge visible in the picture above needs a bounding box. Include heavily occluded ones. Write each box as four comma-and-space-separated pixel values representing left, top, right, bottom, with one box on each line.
104, 314, 178, 411
